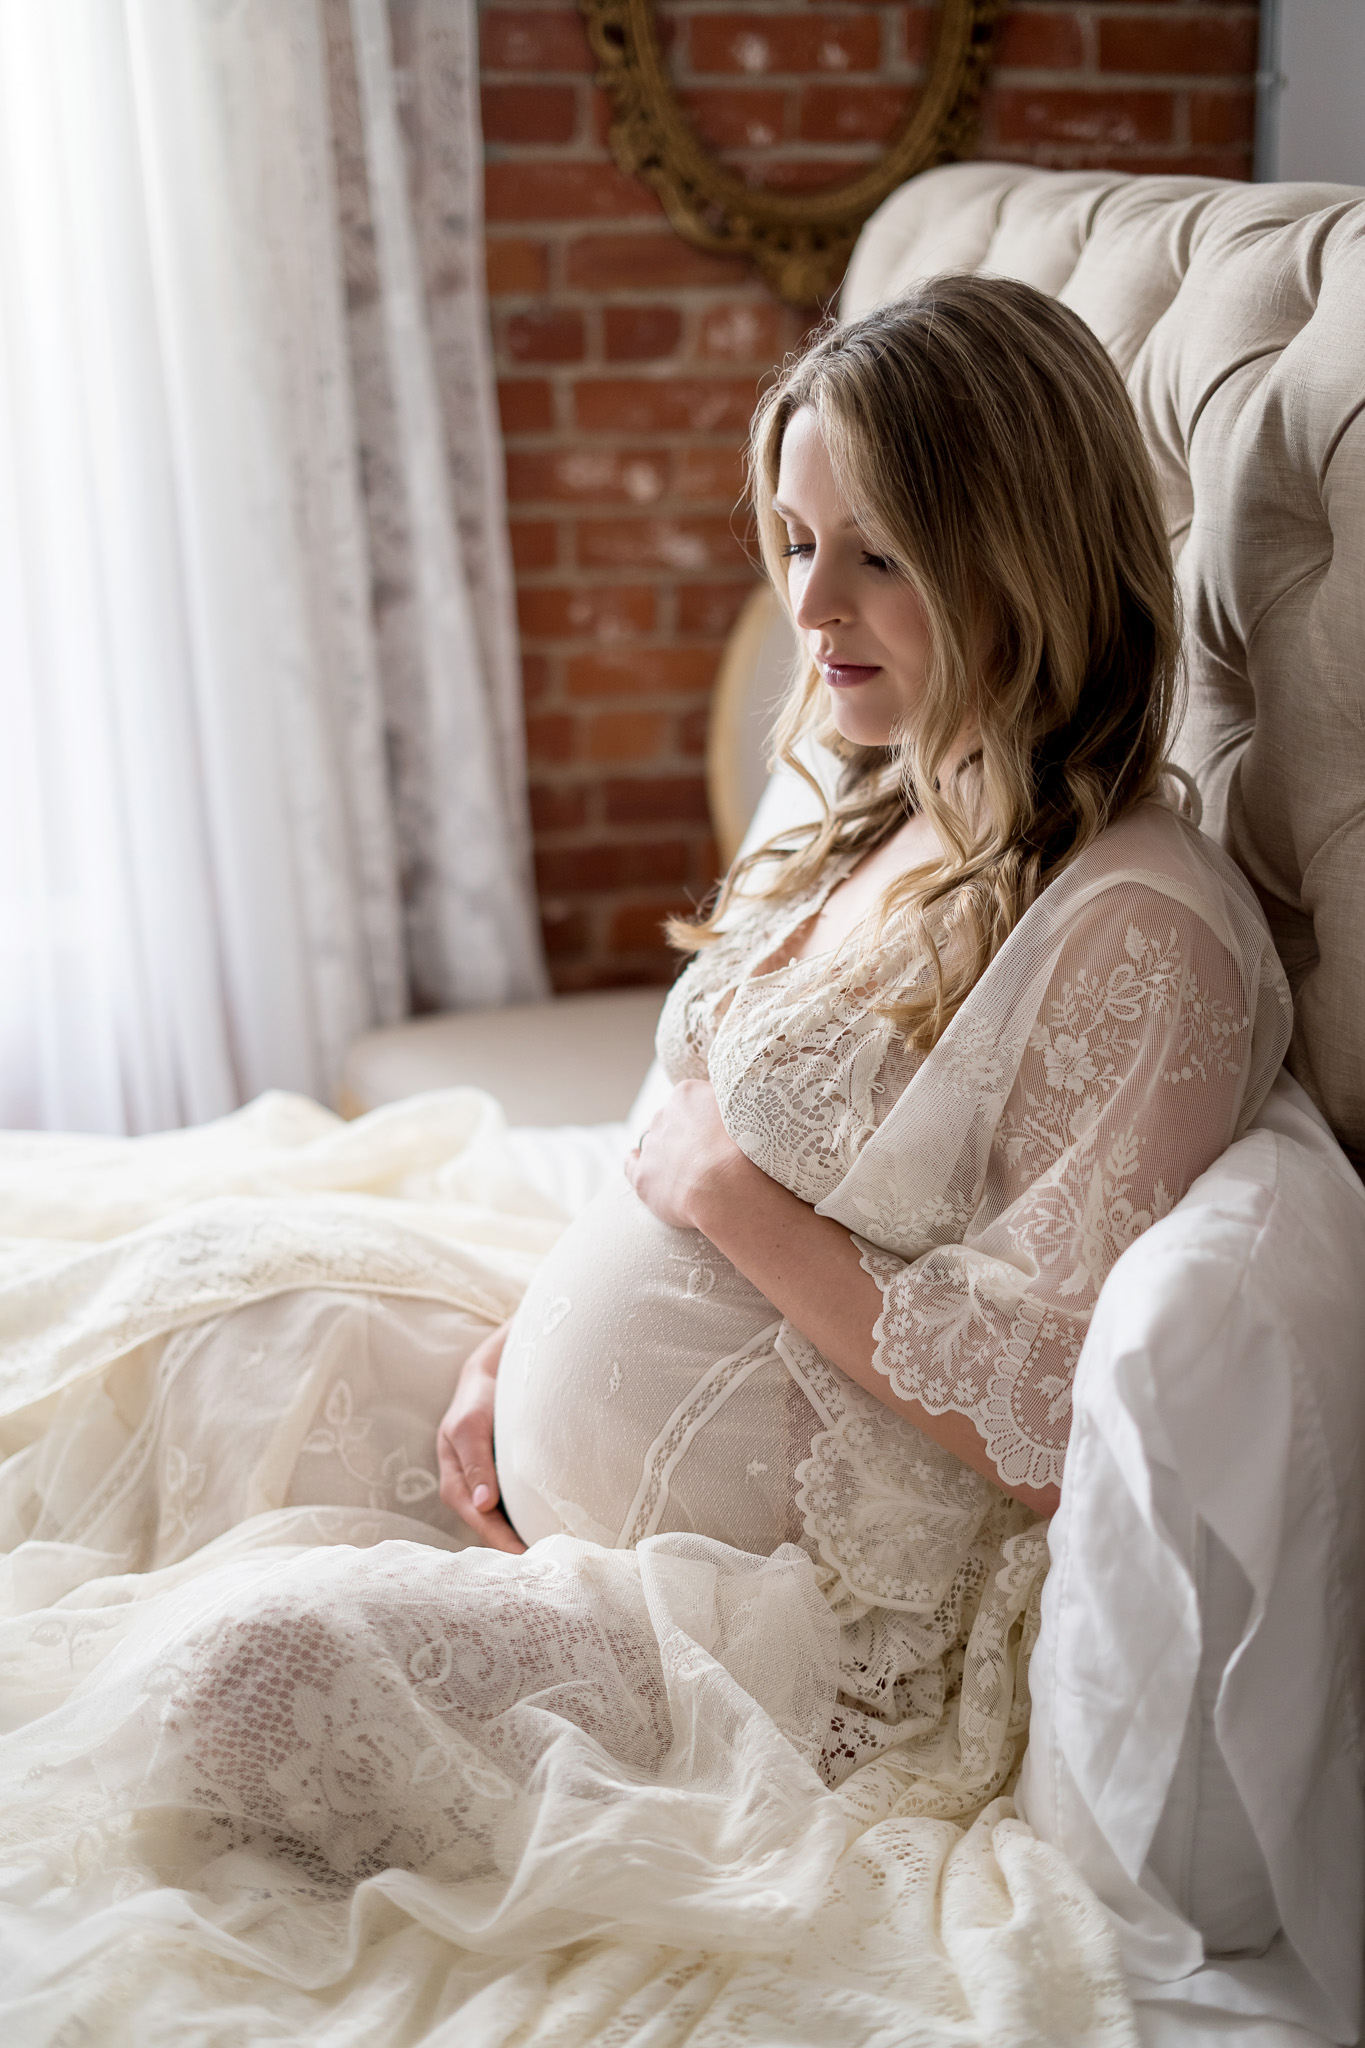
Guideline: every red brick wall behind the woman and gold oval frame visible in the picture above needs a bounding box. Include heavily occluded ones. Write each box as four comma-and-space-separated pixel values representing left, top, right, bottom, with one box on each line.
483, 0, 1257, 987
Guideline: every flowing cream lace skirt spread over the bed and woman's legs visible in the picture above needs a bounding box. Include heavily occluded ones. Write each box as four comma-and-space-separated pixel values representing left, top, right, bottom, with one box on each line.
0, 1114, 1134, 2048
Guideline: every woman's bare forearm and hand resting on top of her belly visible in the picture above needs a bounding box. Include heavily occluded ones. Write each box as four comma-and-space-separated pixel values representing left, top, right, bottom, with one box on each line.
626, 1081, 1060, 1516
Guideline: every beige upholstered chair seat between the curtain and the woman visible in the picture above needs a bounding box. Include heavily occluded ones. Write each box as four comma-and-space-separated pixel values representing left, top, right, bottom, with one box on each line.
340, 989, 667, 1124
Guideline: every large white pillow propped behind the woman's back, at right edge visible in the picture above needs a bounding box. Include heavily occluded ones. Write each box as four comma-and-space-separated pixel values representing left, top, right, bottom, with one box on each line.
1019, 1075, 1365, 2042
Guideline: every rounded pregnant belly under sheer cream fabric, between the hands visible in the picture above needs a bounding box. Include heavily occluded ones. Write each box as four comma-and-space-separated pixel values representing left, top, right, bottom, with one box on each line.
495, 1182, 819, 1554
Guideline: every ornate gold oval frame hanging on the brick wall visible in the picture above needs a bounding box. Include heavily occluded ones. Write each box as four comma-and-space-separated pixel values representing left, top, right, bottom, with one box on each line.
579, 0, 1005, 305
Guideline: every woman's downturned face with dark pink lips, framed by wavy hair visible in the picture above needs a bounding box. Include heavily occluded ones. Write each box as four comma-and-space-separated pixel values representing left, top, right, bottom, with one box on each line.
774, 406, 929, 748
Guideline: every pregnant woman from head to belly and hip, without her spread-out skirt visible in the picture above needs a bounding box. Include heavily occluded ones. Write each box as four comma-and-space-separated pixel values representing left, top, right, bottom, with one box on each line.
440, 279, 1289, 1815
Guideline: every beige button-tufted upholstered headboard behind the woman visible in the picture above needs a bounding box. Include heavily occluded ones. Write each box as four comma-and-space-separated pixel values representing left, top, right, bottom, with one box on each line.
841, 164, 1365, 1165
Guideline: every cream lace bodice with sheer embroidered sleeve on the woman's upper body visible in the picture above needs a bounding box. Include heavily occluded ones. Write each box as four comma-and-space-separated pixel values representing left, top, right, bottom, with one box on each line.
659, 803, 1289, 1487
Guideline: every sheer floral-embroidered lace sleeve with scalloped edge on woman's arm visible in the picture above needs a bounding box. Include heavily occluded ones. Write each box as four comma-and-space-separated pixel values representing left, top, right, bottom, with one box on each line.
855, 881, 1254, 1489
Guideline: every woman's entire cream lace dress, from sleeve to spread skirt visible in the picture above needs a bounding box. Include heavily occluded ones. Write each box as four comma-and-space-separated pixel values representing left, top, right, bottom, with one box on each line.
0, 803, 1289, 2048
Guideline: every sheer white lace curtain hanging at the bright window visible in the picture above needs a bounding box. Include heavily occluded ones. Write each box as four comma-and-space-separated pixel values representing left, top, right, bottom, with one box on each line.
0, 0, 542, 1130
